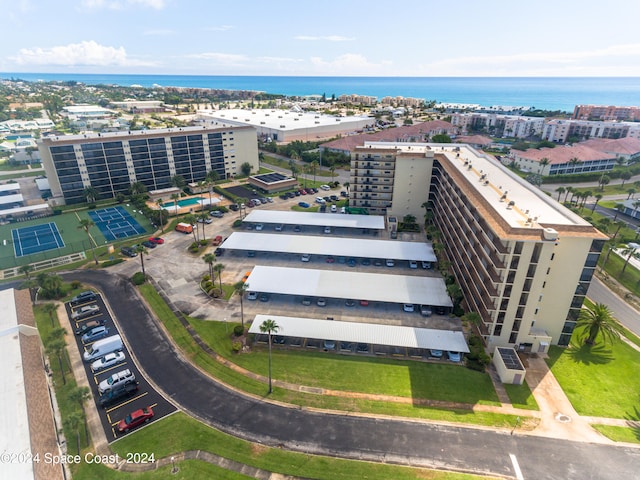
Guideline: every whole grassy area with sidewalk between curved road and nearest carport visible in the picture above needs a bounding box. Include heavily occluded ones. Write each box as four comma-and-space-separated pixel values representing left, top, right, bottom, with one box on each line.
141, 285, 537, 429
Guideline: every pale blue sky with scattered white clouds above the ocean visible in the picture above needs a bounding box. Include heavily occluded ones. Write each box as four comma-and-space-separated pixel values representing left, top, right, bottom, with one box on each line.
0, 0, 640, 76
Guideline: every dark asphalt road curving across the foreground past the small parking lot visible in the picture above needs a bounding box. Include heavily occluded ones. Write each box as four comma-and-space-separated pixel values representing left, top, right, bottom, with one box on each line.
64, 270, 640, 480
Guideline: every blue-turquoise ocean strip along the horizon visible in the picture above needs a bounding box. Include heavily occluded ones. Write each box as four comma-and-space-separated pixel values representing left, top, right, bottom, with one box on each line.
0, 72, 640, 112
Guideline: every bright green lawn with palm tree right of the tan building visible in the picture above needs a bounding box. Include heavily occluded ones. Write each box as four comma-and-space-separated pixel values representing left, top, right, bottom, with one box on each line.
547, 330, 640, 419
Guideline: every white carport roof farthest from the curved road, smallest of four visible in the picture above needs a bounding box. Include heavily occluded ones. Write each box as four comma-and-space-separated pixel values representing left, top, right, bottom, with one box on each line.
244, 210, 385, 230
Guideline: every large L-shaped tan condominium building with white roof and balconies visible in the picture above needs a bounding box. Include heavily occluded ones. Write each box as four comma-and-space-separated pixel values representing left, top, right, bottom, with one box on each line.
350, 143, 607, 352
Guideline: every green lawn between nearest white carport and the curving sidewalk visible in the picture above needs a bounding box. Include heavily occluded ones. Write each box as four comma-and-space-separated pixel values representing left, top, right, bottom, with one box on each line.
189, 319, 499, 405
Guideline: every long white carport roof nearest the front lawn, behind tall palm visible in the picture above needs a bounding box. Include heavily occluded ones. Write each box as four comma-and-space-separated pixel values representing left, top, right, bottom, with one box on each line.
249, 315, 469, 353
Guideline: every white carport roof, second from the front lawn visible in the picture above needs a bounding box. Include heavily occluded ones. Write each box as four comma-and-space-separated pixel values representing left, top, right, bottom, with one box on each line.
247, 265, 453, 307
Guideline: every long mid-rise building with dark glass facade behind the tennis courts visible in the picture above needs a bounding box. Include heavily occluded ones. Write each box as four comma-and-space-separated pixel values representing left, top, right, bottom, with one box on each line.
38, 126, 259, 204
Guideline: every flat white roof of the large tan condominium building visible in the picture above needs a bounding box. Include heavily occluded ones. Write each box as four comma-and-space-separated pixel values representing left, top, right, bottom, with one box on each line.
365, 142, 592, 229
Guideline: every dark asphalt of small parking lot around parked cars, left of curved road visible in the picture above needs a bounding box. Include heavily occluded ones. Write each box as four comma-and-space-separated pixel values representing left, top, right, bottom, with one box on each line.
65, 295, 176, 442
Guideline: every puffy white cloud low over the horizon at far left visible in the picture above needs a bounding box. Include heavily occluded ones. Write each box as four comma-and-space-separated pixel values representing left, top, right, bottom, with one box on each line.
11, 40, 150, 67
